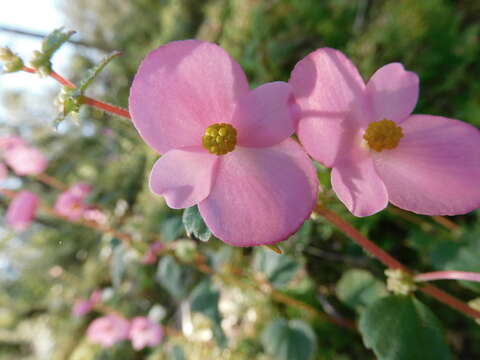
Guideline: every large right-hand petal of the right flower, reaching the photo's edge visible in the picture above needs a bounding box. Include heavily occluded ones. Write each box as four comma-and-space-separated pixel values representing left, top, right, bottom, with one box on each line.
374, 115, 480, 215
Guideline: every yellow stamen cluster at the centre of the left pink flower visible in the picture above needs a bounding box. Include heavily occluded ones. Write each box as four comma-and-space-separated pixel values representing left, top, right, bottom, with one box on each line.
202, 123, 237, 155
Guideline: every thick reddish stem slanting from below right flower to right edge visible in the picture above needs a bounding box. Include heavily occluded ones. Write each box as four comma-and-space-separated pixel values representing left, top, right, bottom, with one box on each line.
315, 205, 480, 319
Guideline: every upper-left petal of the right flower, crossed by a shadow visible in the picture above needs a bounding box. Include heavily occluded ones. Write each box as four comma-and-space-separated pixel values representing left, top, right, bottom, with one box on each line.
289, 48, 371, 167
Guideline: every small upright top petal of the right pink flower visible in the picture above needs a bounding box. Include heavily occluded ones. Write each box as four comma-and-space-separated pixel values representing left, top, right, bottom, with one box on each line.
367, 63, 419, 123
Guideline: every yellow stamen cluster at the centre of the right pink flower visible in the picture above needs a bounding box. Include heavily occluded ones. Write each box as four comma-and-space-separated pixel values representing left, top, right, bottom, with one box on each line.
363, 119, 403, 152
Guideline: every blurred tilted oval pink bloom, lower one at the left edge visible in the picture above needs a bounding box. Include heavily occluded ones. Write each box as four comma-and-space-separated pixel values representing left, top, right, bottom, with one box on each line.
6, 190, 38, 231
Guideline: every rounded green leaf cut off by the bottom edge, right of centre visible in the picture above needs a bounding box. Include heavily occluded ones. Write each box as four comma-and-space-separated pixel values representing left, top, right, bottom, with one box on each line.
261, 318, 317, 360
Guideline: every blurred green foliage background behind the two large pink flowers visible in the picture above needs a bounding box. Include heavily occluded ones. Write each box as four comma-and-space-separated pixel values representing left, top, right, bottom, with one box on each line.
0, 0, 480, 360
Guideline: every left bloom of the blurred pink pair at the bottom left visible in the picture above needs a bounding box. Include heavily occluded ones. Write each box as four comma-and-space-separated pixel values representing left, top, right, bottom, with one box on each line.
87, 315, 130, 348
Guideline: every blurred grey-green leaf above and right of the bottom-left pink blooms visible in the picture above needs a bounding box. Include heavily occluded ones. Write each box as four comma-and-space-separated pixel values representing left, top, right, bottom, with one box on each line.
155, 255, 194, 300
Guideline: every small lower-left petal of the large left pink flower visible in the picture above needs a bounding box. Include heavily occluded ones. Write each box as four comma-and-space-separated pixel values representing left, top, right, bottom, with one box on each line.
150, 147, 218, 209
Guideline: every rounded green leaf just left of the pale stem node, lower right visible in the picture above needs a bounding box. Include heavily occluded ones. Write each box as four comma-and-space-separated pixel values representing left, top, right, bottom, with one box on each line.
336, 269, 388, 311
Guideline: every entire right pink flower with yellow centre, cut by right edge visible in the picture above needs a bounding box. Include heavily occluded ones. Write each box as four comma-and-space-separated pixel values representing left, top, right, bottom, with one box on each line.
290, 48, 480, 216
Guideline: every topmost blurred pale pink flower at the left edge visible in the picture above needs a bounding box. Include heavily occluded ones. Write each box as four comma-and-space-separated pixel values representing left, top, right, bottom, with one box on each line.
5, 146, 48, 176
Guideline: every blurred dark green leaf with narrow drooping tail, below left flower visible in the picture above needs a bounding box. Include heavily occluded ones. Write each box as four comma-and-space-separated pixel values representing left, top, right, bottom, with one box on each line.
191, 279, 227, 348
